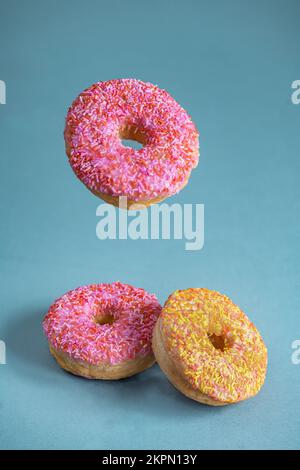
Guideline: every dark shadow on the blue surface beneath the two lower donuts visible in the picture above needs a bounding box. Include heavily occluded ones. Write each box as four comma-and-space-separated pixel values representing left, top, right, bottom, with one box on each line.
5, 308, 230, 419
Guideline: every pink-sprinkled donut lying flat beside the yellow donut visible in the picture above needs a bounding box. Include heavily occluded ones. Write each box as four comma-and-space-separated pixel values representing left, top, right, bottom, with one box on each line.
43, 282, 161, 380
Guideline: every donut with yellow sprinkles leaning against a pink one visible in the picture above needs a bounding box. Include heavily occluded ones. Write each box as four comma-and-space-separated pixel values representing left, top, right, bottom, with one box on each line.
152, 288, 267, 406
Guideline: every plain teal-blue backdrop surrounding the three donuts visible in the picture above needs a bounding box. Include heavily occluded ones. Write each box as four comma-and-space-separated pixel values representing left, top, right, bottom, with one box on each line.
0, 0, 300, 449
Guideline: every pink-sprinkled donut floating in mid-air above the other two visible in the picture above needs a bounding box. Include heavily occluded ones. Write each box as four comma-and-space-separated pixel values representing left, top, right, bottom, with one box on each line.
64, 79, 199, 209
